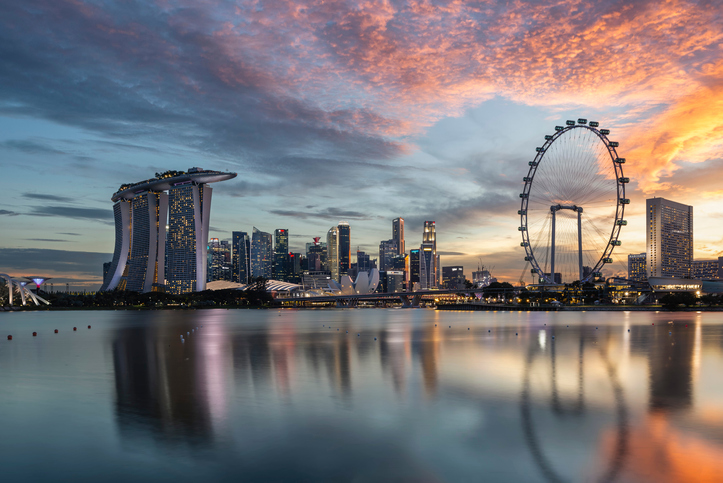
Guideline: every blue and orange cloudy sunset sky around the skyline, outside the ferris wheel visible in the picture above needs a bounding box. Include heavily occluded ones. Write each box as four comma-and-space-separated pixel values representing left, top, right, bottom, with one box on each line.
0, 0, 723, 290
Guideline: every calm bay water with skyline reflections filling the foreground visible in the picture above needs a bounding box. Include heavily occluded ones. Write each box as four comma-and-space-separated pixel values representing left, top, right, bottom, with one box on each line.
0, 309, 723, 483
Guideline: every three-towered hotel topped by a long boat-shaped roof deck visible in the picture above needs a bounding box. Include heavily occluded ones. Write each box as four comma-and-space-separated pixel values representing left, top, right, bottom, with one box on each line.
101, 168, 236, 293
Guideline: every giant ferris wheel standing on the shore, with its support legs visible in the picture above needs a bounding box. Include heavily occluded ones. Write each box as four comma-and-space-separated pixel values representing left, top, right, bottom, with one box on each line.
518, 119, 630, 283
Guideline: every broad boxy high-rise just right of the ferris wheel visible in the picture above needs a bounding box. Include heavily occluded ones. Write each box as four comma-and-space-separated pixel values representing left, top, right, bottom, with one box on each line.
645, 198, 693, 279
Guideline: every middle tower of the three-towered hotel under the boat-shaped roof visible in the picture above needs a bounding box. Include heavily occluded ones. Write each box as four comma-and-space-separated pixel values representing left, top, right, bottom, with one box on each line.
126, 191, 168, 292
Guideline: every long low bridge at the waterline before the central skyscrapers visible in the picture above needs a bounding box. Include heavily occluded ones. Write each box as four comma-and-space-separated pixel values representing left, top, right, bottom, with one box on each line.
276, 288, 484, 308
